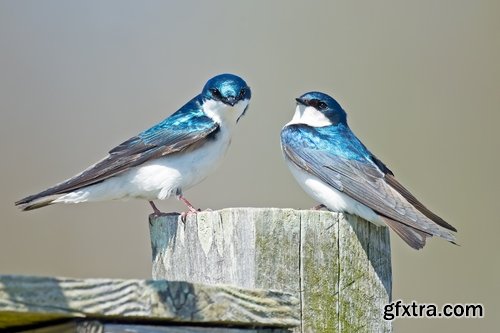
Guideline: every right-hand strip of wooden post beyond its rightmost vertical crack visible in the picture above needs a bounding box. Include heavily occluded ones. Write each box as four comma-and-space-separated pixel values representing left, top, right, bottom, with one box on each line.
338, 215, 392, 333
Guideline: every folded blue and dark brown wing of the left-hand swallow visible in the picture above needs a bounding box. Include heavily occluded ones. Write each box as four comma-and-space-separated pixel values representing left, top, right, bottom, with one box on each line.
16, 98, 219, 205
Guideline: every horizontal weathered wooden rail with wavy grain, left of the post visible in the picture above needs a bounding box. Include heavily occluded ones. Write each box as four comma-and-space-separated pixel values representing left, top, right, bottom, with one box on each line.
0, 275, 299, 328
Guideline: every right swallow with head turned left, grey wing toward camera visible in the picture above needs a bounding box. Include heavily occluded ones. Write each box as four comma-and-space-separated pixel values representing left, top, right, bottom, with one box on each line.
281, 92, 457, 249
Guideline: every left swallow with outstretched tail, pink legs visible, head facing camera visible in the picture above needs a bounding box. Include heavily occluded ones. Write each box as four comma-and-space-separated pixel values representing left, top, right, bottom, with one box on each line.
15, 74, 252, 214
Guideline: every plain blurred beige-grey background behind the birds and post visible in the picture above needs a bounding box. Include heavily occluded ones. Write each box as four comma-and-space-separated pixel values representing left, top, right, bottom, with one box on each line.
0, 0, 500, 332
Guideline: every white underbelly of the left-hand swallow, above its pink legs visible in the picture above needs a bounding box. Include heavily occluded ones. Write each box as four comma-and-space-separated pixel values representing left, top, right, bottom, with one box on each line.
55, 132, 231, 203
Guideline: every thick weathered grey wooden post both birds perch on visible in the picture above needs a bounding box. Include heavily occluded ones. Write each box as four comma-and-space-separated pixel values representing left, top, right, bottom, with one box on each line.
150, 208, 392, 332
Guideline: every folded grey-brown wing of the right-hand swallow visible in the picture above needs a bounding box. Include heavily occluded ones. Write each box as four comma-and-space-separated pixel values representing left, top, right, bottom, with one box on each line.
282, 124, 454, 241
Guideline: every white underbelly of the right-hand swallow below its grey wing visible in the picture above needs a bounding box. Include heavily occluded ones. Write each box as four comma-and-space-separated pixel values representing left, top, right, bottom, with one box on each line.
285, 157, 385, 226
